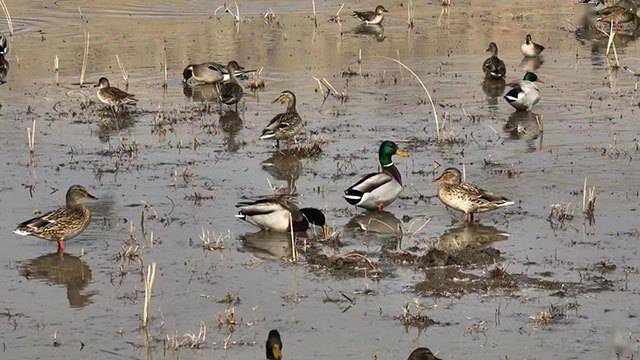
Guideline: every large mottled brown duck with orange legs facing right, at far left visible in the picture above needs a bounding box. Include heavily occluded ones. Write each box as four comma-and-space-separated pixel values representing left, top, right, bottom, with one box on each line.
14, 185, 97, 252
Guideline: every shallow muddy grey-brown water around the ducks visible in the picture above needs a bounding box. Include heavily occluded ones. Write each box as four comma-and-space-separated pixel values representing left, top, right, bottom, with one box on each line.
0, 1, 640, 359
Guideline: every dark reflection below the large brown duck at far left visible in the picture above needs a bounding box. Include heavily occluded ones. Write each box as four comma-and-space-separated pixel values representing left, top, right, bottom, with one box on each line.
18, 252, 95, 308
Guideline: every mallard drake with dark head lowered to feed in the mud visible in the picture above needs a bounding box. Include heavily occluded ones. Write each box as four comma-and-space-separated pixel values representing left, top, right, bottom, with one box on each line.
236, 196, 329, 238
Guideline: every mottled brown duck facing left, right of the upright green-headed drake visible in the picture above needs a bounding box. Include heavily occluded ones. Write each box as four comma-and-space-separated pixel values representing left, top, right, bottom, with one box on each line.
433, 168, 514, 223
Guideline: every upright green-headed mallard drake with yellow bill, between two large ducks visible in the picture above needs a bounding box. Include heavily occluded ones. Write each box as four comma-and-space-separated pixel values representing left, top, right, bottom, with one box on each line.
344, 140, 409, 212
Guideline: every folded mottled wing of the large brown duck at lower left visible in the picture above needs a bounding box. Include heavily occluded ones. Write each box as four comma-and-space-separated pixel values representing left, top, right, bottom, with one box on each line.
14, 208, 86, 240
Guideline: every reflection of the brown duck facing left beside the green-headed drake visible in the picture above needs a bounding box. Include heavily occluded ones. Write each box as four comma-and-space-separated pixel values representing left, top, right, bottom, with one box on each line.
436, 223, 509, 251
